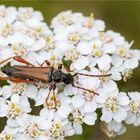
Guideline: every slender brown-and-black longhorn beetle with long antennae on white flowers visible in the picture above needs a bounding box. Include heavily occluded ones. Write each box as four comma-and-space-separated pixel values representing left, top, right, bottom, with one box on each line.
0, 56, 111, 109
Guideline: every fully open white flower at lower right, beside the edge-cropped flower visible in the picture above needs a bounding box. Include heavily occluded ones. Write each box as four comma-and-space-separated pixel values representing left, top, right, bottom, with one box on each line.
97, 84, 129, 123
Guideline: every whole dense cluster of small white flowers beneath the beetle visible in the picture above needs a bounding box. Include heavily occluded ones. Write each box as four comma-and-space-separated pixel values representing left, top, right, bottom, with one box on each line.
0, 6, 140, 140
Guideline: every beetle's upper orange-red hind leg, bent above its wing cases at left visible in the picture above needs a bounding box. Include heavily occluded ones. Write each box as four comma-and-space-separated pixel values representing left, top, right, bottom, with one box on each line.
0, 56, 34, 66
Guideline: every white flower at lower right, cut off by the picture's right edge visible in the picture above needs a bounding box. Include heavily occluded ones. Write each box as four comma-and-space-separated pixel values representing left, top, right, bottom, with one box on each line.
126, 92, 140, 126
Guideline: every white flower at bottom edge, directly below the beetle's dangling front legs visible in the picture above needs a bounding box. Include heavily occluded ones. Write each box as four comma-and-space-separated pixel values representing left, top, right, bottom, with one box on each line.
40, 108, 75, 139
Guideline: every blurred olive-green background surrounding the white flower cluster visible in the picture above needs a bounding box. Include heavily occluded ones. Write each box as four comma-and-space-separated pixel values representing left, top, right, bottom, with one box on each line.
0, 0, 140, 140
